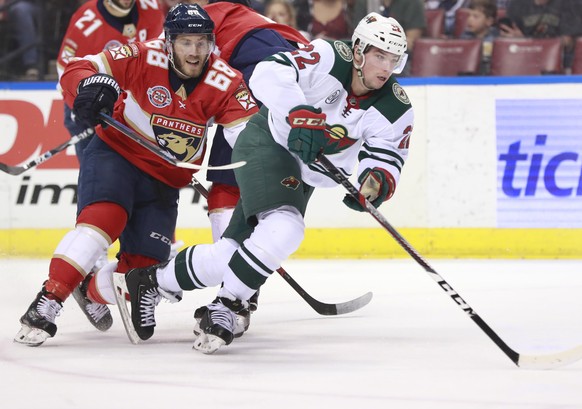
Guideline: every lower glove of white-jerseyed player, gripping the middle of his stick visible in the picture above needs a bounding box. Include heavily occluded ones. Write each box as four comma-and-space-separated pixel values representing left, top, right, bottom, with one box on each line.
344, 168, 395, 212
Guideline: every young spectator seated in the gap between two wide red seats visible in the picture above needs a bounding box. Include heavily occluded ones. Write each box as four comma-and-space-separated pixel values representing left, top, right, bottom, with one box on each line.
461, 0, 499, 75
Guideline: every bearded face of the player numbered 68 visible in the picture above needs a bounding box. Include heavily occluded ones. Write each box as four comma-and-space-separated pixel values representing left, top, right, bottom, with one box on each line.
174, 34, 212, 78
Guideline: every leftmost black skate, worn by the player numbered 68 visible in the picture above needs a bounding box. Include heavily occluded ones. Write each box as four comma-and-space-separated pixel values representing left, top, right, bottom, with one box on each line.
14, 284, 63, 347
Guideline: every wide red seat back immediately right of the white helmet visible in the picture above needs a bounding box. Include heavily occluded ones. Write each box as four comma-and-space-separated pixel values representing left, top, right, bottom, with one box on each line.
411, 38, 481, 77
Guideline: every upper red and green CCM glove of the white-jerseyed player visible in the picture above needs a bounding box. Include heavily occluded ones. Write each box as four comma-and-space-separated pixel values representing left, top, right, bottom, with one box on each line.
287, 105, 327, 163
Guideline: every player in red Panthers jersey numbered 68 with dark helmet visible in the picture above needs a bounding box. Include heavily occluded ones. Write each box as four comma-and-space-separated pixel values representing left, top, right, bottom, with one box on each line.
15, 4, 257, 346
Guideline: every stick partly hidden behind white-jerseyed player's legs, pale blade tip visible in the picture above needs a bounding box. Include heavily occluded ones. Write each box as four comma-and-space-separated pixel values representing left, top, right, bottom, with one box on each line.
192, 177, 373, 315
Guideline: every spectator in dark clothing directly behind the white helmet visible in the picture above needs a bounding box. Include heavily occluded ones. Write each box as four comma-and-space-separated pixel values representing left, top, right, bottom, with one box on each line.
380, 0, 426, 76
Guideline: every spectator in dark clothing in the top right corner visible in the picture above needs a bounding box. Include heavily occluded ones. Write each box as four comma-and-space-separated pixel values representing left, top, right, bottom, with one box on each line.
499, 0, 580, 67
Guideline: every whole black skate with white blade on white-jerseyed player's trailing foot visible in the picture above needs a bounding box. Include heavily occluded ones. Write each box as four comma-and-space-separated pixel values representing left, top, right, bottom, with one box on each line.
113, 262, 182, 343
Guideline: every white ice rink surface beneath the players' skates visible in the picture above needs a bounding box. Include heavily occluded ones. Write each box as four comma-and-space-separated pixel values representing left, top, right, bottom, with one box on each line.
0, 259, 582, 409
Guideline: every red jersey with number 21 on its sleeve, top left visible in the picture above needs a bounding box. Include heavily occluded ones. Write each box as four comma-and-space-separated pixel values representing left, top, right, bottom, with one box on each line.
57, 0, 165, 75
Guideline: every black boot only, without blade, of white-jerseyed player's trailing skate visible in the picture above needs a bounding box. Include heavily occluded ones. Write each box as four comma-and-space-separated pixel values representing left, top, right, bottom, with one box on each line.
125, 262, 182, 341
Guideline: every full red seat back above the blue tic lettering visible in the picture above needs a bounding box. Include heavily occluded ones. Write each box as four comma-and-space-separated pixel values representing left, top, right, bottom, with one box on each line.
491, 38, 562, 76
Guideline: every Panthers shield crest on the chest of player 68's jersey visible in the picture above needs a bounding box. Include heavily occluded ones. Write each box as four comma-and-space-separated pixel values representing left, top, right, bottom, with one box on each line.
151, 114, 206, 162
